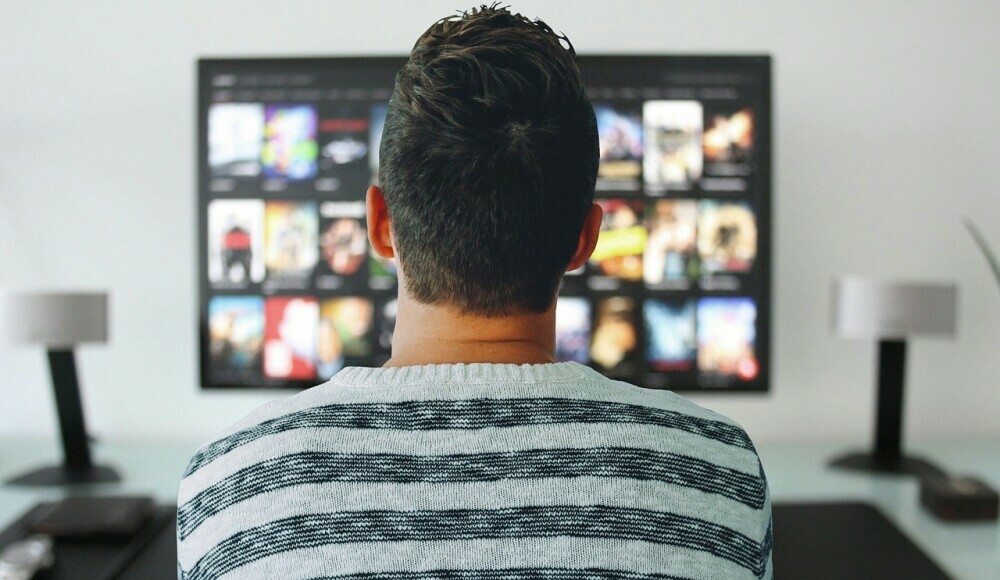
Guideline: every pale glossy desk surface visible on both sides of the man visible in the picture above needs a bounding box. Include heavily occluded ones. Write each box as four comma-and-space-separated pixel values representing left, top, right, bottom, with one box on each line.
0, 438, 1000, 580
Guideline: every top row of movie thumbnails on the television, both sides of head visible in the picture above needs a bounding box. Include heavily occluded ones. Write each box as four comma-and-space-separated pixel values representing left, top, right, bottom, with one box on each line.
208, 100, 755, 196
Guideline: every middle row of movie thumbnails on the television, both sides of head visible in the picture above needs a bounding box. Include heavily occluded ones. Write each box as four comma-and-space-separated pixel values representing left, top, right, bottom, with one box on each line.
207, 193, 757, 293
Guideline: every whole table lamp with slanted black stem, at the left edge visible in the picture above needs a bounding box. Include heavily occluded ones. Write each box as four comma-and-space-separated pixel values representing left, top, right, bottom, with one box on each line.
0, 292, 120, 485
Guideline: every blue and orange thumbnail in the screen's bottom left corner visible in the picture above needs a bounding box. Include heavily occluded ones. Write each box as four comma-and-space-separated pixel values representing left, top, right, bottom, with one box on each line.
208, 296, 264, 375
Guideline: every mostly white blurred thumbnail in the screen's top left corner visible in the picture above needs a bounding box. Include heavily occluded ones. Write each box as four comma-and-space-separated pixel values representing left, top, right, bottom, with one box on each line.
208, 103, 264, 177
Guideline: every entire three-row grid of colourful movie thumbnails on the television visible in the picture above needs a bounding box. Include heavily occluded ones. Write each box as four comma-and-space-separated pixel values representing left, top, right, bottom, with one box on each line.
207, 100, 759, 387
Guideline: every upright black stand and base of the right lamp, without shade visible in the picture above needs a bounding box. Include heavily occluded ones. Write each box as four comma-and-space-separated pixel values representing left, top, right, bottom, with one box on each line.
830, 340, 945, 477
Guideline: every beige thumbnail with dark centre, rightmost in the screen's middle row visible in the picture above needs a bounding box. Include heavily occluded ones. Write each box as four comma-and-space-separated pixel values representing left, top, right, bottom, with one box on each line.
698, 200, 757, 274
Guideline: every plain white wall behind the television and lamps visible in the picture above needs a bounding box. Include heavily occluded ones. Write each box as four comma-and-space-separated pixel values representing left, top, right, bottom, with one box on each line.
0, 0, 1000, 443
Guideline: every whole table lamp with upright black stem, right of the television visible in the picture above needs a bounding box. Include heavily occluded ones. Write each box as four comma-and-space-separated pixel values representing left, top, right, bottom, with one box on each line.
831, 277, 958, 476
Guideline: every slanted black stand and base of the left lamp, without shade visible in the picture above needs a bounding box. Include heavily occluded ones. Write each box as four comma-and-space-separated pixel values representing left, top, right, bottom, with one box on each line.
7, 349, 121, 485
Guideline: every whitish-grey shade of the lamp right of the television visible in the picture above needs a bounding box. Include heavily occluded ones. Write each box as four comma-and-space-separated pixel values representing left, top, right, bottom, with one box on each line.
832, 276, 958, 339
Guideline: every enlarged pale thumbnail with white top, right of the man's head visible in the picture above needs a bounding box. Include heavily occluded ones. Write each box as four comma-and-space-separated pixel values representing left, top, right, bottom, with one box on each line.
642, 101, 704, 190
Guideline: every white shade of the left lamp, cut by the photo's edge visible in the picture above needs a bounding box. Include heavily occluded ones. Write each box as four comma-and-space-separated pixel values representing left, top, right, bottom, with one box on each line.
0, 292, 108, 348
